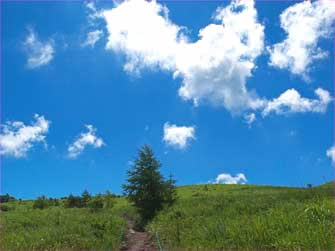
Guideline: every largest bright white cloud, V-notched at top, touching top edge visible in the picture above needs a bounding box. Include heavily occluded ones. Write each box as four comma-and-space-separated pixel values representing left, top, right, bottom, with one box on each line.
102, 0, 264, 111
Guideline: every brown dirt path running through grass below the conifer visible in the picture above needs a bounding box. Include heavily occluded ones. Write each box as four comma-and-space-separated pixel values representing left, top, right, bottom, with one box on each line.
121, 217, 158, 251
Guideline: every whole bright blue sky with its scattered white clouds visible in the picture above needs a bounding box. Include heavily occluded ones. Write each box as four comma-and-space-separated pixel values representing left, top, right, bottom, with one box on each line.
0, 0, 335, 199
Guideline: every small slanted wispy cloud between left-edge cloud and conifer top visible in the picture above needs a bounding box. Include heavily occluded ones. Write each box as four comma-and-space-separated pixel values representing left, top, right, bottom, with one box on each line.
68, 125, 105, 158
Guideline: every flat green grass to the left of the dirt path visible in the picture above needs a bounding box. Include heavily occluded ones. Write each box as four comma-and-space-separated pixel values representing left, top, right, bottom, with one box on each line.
0, 198, 134, 250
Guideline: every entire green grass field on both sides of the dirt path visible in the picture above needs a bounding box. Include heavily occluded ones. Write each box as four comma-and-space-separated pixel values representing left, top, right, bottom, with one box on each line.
0, 183, 335, 250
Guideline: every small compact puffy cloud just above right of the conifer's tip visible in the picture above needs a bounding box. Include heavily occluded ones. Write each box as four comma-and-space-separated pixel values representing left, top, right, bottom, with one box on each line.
163, 122, 195, 149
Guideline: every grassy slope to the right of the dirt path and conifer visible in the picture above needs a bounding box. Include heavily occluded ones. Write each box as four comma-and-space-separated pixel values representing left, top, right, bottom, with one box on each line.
148, 183, 334, 250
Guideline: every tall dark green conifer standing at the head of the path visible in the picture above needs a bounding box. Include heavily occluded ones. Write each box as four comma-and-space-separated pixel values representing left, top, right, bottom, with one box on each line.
123, 145, 175, 223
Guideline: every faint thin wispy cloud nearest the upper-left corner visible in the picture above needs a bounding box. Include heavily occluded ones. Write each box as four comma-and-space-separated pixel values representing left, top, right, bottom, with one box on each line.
24, 29, 55, 69
